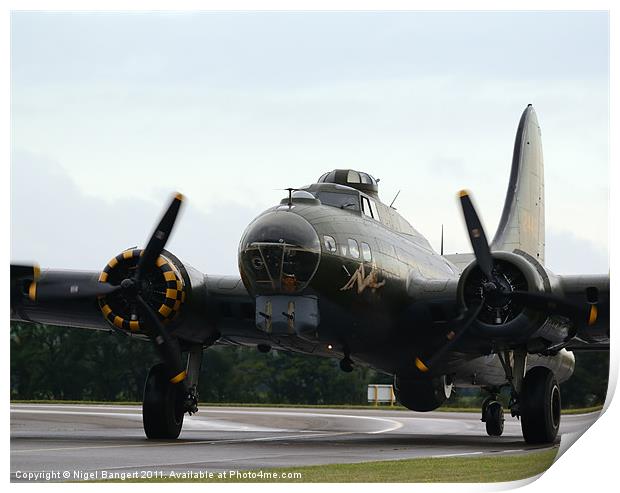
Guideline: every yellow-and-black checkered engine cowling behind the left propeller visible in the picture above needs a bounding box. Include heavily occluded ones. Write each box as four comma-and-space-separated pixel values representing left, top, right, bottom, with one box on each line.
99, 248, 185, 332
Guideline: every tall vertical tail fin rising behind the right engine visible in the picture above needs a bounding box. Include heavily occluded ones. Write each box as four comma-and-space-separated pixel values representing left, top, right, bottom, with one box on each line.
491, 104, 545, 264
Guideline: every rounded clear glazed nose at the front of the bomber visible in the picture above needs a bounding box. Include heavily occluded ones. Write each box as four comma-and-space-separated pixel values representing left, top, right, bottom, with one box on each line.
239, 211, 321, 295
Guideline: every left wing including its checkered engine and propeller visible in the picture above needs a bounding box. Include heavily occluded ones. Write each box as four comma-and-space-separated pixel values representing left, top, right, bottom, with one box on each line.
10, 193, 280, 356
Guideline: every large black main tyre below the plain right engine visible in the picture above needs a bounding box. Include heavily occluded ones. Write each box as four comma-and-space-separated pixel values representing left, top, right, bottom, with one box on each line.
519, 366, 562, 444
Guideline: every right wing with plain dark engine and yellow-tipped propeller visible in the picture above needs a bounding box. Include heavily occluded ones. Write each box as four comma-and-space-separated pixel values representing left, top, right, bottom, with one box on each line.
407, 184, 610, 371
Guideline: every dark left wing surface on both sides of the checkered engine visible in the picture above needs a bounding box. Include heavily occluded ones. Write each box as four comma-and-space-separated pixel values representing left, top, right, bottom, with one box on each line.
10, 264, 267, 344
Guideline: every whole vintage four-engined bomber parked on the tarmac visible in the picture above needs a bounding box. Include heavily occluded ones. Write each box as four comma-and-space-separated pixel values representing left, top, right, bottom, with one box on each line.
11, 105, 609, 443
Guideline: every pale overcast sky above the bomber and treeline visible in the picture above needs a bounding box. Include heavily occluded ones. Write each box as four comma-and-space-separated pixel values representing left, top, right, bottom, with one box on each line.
11, 12, 609, 274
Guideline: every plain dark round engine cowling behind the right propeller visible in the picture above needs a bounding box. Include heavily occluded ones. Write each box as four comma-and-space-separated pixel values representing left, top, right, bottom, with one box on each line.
457, 252, 551, 341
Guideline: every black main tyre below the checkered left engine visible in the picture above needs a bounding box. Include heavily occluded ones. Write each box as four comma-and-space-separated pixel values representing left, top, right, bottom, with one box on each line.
142, 363, 185, 440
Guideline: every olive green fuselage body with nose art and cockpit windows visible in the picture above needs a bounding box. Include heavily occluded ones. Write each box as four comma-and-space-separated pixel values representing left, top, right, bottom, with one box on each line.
240, 184, 458, 373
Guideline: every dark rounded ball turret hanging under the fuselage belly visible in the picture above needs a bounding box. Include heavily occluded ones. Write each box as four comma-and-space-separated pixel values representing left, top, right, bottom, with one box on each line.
394, 375, 452, 412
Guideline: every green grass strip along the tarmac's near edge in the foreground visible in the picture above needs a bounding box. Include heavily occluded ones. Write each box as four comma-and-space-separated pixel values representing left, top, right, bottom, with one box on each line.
109, 447, 557, 483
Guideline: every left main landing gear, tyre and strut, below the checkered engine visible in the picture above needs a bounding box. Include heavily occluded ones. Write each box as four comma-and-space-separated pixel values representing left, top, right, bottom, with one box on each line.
142, 347, 202, 440
